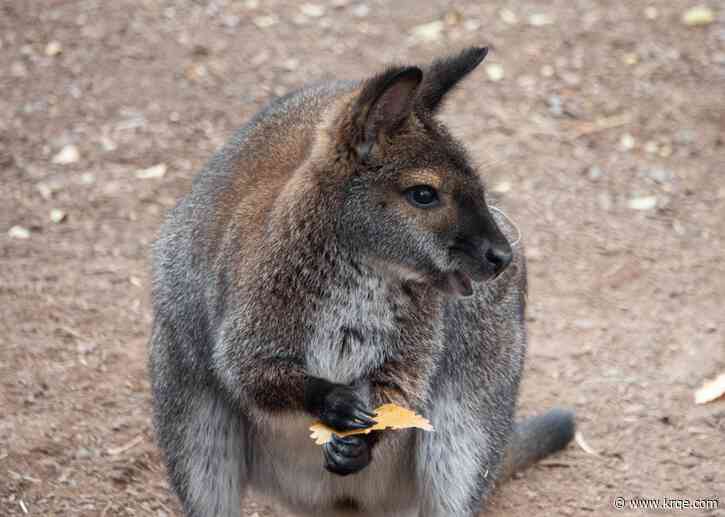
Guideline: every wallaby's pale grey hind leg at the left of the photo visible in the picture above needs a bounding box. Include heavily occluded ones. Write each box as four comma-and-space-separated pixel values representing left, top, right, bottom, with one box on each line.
151, 330, 247, 517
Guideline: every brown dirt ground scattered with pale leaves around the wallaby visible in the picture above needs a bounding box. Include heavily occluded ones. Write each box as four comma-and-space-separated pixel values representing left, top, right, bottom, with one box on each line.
0, 0, 725, 517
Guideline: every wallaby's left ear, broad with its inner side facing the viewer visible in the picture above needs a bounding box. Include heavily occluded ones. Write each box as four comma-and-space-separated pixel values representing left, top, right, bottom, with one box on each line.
351, 67, 423, 157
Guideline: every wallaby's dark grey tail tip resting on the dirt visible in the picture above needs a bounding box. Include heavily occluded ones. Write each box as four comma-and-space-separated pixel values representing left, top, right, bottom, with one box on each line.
501, 409, 574, 479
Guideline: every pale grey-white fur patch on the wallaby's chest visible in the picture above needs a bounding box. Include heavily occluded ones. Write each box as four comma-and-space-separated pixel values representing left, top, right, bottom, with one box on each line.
306, 277, 400, 384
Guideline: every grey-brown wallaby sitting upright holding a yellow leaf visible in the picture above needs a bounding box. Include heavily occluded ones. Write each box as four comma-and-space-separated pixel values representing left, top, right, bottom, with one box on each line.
150, 48, 574, 517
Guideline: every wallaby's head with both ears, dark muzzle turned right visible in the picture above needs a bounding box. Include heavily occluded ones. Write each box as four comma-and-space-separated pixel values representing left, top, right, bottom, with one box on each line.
334, 48, 512, 295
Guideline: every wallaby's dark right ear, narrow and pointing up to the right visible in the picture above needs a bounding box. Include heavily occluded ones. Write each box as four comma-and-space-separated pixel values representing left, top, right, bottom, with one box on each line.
420, 47, 488, 113
